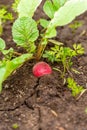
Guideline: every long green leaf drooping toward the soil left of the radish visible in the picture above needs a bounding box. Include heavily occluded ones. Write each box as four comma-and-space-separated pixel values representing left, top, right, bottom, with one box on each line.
0, 54, 32, 91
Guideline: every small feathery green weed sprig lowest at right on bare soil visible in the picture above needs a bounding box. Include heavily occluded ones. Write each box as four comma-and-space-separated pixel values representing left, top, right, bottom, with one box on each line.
67, 78, 84, 97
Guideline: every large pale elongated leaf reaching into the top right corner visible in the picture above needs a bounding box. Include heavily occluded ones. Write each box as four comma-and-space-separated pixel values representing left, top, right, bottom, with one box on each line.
47, 0, 87, 33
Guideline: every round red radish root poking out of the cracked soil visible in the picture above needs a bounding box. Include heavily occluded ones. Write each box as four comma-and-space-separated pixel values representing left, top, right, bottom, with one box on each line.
33, 61, 52, 77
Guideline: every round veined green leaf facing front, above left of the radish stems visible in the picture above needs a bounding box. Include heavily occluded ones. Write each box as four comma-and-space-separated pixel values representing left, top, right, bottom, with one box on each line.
12, 17, 39, 47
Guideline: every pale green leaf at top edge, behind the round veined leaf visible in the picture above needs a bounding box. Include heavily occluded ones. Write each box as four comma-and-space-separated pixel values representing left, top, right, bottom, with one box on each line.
17, 0, 42, 17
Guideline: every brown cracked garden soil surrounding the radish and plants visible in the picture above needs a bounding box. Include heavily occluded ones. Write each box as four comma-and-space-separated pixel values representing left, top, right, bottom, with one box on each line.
0, 0, 87, 130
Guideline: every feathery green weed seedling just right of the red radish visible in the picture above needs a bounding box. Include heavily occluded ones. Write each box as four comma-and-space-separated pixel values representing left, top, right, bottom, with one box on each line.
43, 44, 84, 76
